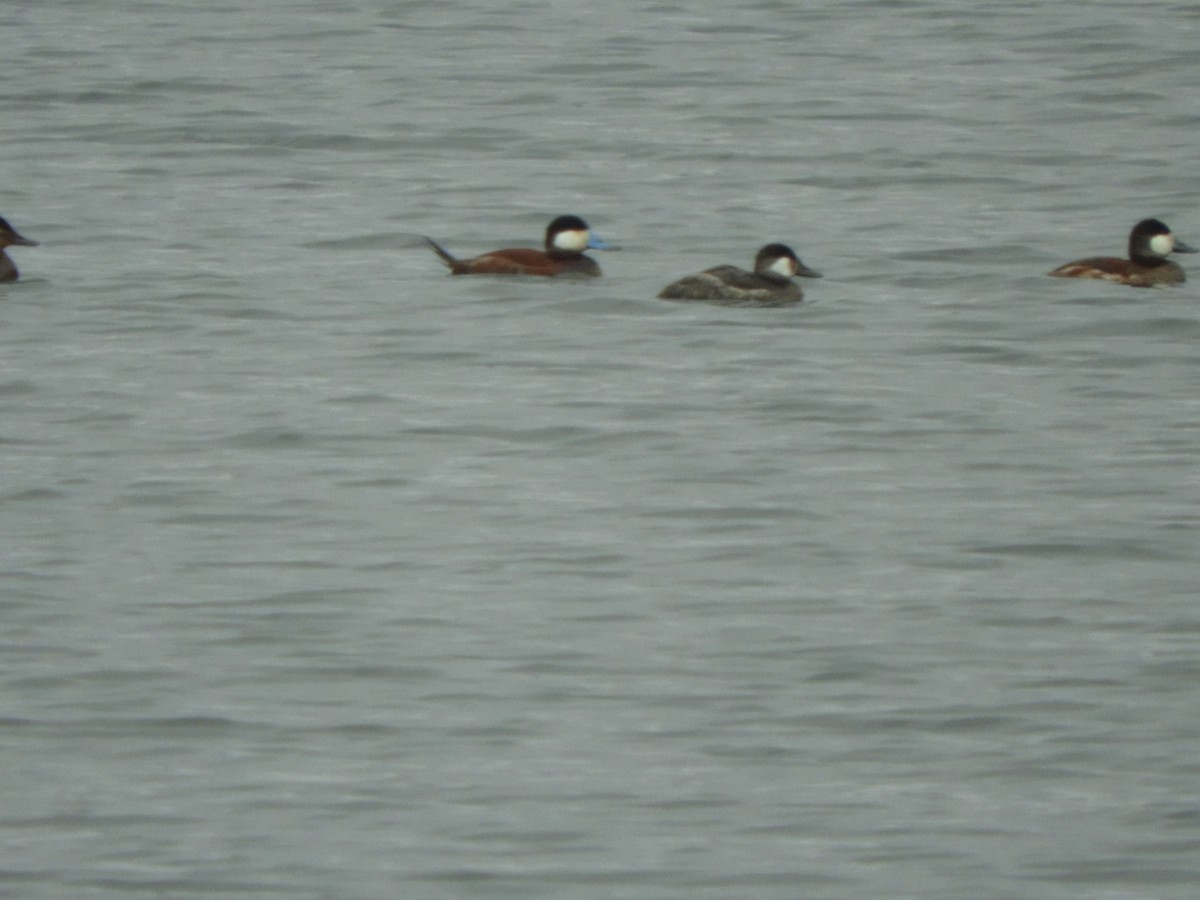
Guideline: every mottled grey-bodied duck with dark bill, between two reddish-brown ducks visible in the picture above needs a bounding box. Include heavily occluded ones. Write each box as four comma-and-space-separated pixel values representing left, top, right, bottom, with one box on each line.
659, 244, 821, 306
